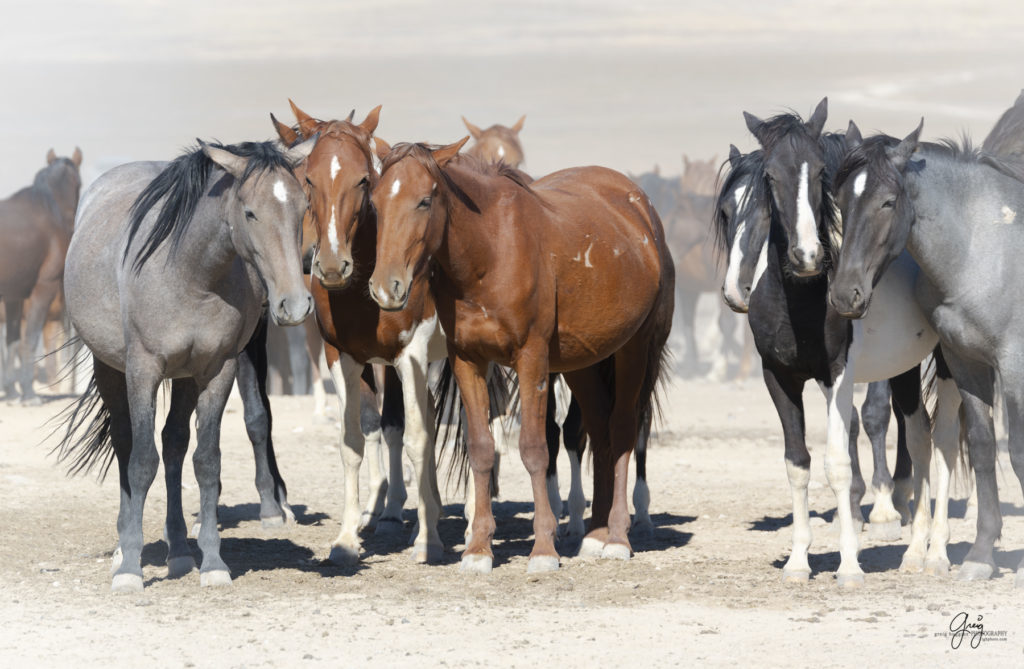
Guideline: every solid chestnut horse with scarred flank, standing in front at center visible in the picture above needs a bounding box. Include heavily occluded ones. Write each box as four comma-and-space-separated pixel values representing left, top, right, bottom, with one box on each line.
370, 137, 675, 573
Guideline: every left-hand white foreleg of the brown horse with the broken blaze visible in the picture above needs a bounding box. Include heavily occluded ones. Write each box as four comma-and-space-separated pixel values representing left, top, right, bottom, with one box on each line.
326, 345, 366, 565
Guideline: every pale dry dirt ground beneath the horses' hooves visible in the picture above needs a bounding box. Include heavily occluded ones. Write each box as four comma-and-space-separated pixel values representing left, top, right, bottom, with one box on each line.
0, 368, 1024, 667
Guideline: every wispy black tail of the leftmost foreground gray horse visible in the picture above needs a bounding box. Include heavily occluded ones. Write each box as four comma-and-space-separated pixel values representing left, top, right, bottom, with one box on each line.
50, 374, 114, 480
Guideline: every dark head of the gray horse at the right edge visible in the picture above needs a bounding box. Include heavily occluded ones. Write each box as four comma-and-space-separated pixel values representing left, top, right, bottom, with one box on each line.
828, 127, 921, 319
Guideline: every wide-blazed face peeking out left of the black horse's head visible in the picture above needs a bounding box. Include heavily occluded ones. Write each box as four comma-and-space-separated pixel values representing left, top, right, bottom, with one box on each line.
719, 179, 771, 313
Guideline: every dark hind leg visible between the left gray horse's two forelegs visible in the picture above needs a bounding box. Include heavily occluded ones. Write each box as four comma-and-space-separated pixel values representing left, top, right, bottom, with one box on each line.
161, 379, 199, 579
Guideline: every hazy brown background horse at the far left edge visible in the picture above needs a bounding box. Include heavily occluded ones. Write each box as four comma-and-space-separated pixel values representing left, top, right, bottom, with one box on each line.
0, 148, 82, 404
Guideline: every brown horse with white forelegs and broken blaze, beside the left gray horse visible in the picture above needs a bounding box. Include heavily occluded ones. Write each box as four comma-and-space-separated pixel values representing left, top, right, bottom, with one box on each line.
280, 103, 444, 562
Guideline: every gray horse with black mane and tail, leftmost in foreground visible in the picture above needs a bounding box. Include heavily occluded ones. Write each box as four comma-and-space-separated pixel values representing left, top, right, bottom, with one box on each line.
56, 138, 315, 591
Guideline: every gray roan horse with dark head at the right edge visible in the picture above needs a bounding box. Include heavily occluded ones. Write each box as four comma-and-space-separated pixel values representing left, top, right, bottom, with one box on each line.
829, 121, 1024, 587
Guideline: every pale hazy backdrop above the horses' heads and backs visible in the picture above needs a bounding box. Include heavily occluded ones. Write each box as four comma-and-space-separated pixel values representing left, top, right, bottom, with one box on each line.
0, 0, 1024, 196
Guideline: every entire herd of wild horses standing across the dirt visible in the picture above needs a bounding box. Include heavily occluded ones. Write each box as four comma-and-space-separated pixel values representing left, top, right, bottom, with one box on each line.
0, 87, 1024, 591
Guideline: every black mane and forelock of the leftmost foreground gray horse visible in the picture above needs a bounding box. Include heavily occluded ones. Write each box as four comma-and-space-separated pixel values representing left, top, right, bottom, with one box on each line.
122, 141, 295, 274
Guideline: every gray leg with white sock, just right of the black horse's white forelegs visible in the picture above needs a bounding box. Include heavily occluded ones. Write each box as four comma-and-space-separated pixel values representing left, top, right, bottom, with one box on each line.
860, 381, 902, 541
